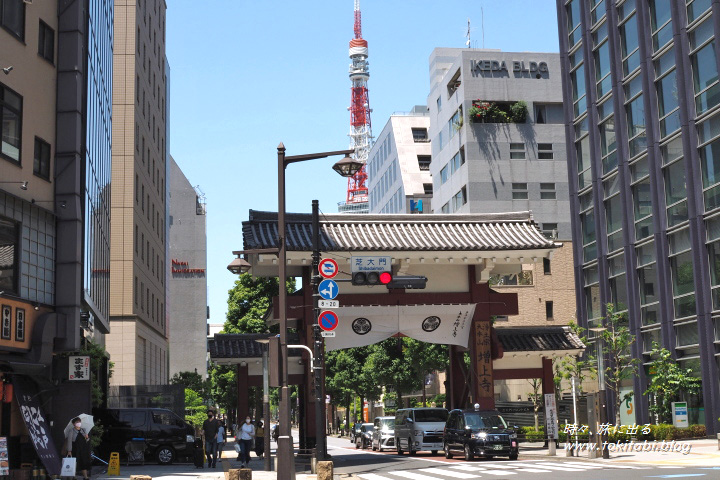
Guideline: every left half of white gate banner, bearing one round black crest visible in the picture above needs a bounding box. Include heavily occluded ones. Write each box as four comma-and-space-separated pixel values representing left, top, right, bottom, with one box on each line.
325, 306, 398, 350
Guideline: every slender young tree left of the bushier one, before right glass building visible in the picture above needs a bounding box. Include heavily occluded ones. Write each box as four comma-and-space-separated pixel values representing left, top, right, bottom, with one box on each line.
601, 303, 640, 425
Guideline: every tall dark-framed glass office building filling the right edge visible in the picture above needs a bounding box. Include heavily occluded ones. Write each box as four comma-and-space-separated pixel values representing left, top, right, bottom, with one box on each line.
557, 0, 720, 434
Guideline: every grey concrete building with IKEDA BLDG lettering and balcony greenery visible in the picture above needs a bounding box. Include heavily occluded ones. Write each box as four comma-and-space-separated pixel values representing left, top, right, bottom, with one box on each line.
428, 48, 570, 240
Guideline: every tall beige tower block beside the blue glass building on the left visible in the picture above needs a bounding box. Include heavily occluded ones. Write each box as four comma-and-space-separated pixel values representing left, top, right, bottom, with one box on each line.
107, 0, 169, 385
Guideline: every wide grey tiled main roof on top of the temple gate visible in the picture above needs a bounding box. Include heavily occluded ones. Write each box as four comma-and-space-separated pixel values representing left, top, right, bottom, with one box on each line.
243, 210, 556, 252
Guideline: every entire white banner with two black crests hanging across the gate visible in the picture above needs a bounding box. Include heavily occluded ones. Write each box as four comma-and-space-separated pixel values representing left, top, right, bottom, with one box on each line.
325, 304, 475, 350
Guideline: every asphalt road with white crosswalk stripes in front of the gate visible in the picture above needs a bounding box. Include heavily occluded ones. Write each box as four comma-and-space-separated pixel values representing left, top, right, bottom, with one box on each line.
328, 438, 720, 480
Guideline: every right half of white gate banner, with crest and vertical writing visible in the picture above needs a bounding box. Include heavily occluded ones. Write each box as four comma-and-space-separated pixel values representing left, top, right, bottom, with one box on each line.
399, 304, 475, 348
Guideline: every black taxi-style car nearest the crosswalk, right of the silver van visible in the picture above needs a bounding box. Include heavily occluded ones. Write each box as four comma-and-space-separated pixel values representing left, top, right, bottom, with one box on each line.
443, 408, 518, 461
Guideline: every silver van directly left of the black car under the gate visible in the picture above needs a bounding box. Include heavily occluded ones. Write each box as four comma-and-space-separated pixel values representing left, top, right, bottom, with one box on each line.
395, 408, 448, 455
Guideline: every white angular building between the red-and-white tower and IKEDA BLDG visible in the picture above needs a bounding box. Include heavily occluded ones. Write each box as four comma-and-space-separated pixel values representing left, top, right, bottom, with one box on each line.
366, 105, 432, 213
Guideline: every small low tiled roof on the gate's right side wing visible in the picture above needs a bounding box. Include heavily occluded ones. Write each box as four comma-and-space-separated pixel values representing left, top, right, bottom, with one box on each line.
495, 326, 585, 352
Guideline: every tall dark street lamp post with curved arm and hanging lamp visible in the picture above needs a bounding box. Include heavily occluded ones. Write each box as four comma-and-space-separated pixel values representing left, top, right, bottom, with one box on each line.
277, 143, 362, 480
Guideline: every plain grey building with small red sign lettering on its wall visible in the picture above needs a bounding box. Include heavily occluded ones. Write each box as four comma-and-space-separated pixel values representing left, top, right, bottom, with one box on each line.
168, 157, 209, 378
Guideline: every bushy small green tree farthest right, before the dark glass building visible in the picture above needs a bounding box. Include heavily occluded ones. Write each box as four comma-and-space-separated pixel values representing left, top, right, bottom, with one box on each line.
643, 342, 702, 423
